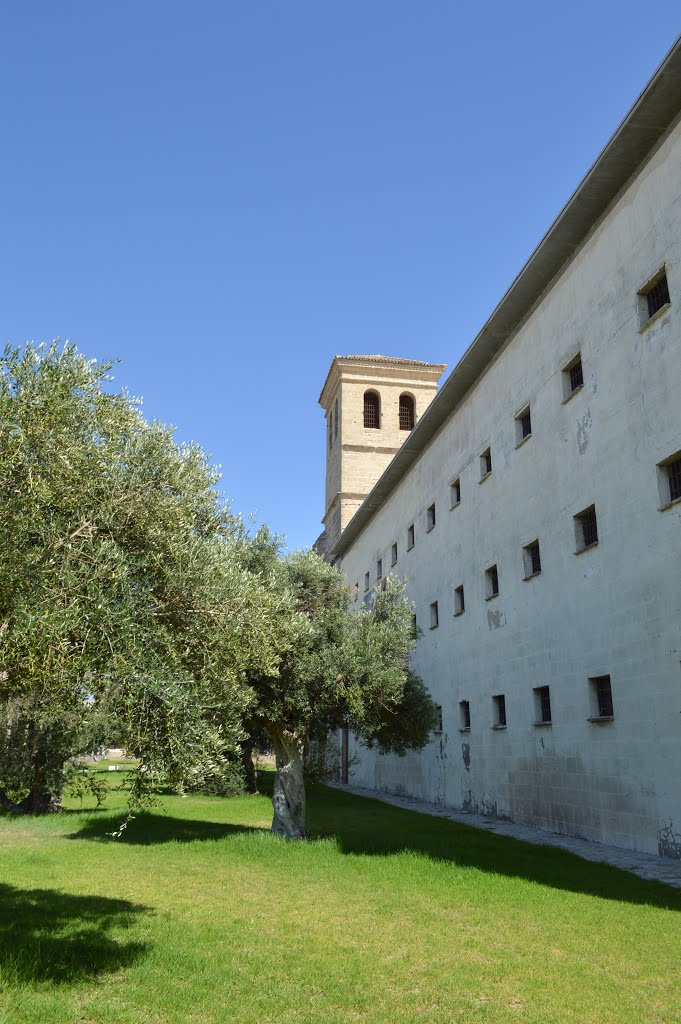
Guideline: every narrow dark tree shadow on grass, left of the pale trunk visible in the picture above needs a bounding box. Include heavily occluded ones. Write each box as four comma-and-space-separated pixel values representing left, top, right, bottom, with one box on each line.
66, 812, 265, 846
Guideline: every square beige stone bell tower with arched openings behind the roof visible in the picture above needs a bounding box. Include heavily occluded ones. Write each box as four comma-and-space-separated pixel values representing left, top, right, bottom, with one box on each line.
315, 355, 446, 556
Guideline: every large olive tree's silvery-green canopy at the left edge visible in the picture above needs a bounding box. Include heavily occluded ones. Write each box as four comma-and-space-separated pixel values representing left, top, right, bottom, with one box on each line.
0, 344, 300, 813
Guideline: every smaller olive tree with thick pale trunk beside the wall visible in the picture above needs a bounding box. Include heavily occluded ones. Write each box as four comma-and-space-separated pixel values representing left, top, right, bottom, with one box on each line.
249, 552, 437, 839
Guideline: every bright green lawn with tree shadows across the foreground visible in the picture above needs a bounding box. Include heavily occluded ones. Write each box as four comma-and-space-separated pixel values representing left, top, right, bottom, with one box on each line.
0, 765, 681, 1024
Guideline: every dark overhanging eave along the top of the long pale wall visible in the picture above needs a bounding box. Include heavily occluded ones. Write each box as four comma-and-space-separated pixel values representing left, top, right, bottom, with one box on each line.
334, 37, 681, 557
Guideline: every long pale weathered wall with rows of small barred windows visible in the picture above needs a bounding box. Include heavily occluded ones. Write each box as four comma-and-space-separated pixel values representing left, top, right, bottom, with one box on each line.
333, 112, 681, 857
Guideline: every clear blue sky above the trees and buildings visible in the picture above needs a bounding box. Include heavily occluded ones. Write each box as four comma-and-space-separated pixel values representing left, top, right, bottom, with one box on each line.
0, 6, 681, 547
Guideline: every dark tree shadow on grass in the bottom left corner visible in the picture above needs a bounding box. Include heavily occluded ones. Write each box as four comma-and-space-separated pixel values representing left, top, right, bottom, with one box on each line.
0, 884, 148, 988
